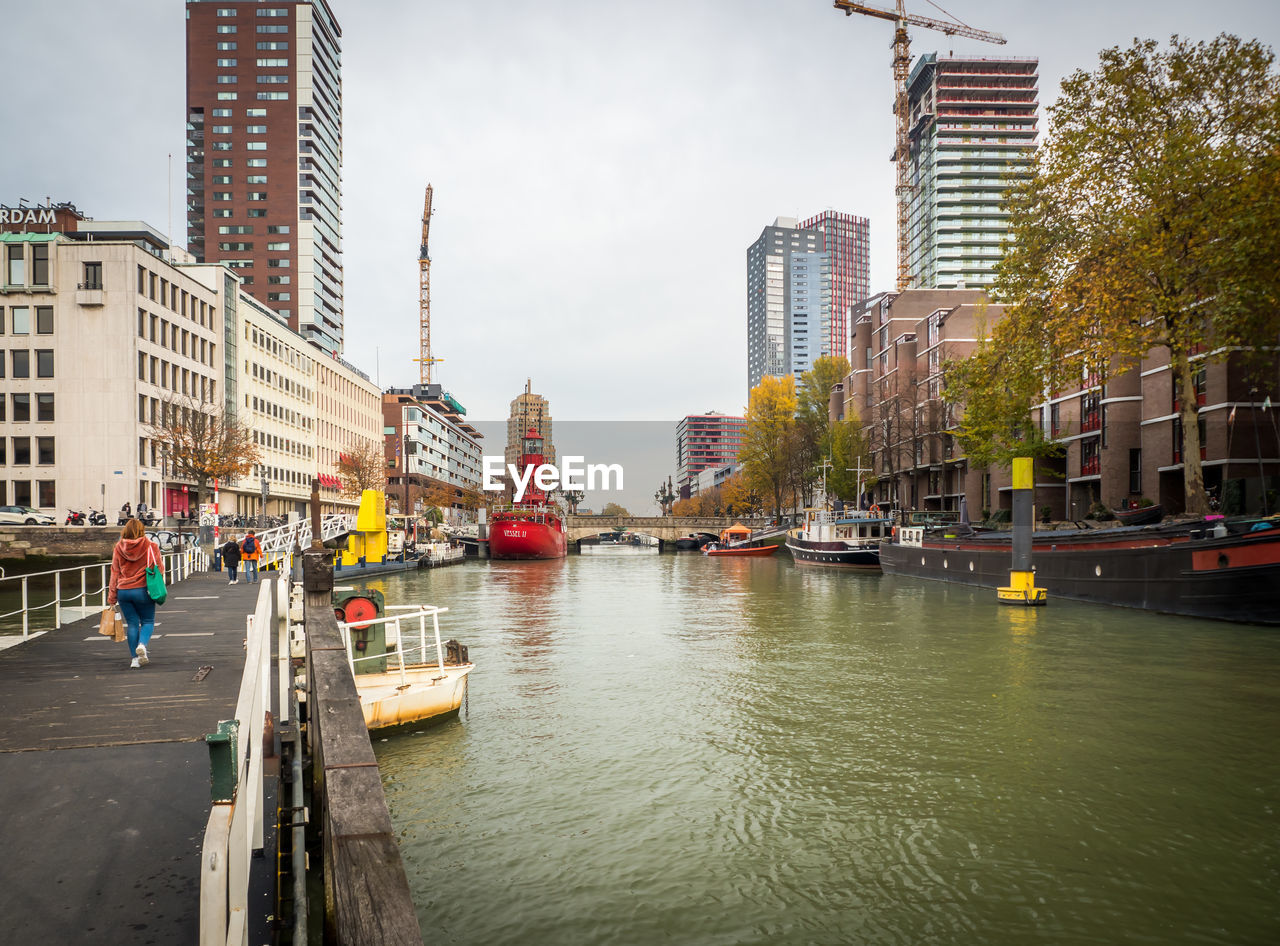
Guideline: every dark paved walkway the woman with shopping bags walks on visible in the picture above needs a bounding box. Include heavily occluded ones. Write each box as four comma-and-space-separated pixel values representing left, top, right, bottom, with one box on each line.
0, 573, 275, 946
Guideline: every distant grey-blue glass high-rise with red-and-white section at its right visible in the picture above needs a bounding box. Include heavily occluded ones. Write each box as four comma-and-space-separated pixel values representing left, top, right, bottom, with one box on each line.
746, 210, 870, 389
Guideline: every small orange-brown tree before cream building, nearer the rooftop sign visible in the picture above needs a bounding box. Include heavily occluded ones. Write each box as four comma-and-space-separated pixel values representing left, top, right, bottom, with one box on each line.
147, 394, 260, 504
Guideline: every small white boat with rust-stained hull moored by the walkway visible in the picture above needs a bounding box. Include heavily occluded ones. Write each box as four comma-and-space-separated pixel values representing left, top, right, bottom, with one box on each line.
338, 605, 475, 731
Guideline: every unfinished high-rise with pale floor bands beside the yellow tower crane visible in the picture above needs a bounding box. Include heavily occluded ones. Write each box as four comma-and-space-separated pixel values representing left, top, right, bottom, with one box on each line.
899, 52, 1039, 289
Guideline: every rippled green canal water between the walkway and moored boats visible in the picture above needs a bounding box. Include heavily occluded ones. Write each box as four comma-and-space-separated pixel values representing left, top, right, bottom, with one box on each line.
374, 554, 1280, 946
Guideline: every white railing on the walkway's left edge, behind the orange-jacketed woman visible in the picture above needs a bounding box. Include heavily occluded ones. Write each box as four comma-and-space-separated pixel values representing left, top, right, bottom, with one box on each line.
0, 548, 209, 640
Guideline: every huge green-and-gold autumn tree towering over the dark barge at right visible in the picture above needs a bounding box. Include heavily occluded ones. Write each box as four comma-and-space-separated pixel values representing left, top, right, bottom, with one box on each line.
963, 35, 1280, 515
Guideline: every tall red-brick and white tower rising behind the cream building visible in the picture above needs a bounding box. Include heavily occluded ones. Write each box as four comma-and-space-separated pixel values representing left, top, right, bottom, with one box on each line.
187, 0, 343, 356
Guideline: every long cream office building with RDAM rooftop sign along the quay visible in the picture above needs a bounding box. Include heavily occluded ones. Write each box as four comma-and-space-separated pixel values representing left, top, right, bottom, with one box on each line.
0, 204, 383, 517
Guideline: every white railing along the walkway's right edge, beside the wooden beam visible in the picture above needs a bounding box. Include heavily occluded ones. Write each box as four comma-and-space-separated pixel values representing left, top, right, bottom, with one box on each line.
200, 556, 291, 946
